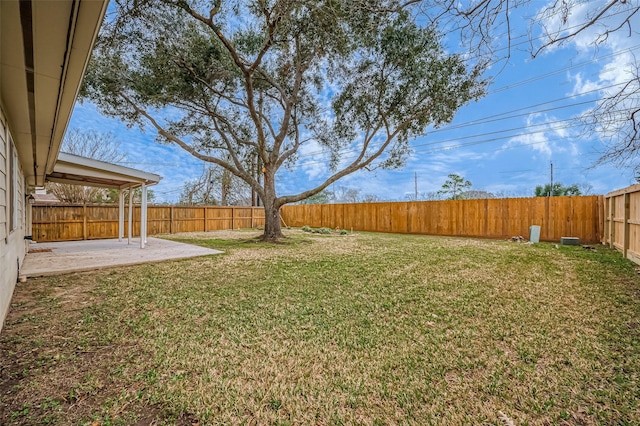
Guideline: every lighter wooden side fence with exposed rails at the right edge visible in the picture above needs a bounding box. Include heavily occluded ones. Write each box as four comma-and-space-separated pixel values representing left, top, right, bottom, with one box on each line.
602, 185, 640, 264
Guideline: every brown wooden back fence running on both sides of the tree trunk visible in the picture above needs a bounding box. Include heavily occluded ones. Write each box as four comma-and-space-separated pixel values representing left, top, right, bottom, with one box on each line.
32, 196, 604, 243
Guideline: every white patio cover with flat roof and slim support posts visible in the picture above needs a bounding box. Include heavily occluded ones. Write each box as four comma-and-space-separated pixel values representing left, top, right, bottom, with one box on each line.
47, 152, 162, 248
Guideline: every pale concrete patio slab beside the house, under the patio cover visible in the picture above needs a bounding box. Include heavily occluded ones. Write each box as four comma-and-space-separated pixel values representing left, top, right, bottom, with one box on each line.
20, 238, 222, 278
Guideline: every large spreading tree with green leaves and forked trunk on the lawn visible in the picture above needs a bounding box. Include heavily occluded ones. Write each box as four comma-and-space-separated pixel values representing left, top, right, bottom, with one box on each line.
83, 0, 485, 239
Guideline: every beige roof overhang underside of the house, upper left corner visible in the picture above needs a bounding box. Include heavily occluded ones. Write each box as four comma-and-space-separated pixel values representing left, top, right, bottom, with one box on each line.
0, 0, 107, 186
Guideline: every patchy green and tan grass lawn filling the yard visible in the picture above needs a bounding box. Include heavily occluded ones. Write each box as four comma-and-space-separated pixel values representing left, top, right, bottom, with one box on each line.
0, 231, 640, 426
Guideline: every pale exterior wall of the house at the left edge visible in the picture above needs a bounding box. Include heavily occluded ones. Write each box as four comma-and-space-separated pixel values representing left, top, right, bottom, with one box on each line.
0, 105, 28, 330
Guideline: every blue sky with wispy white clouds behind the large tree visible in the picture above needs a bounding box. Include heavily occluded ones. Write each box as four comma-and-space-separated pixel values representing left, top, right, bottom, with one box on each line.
69, 1, 640, 202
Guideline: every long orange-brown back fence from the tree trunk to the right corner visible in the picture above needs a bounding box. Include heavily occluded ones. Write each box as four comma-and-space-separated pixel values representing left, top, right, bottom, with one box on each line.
281, 196, 604, 243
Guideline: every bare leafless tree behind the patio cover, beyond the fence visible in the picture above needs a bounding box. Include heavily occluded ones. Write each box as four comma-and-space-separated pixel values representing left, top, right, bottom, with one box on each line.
45, 129, 126, 204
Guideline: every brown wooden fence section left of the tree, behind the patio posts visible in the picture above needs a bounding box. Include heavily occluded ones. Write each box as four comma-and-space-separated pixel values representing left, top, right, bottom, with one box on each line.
32, 204, 264, 242
